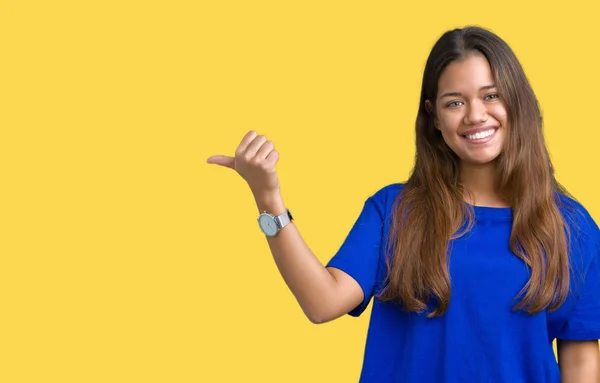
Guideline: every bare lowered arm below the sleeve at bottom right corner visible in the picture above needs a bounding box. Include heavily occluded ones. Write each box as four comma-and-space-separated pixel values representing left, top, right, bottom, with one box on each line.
557, 339, 600, 383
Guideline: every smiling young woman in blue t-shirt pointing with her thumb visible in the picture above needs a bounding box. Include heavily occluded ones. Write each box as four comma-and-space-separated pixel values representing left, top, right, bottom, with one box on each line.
208, 27, 600, 383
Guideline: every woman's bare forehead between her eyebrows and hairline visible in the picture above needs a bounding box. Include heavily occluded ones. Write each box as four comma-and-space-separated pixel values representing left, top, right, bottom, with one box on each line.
438, 54, 494, 94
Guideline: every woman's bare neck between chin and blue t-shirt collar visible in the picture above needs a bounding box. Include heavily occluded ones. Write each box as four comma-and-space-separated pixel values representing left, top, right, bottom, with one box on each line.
460, 162, 508, 207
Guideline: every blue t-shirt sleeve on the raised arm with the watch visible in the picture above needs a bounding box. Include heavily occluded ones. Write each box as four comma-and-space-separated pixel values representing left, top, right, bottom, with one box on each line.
326, 195, 385, 317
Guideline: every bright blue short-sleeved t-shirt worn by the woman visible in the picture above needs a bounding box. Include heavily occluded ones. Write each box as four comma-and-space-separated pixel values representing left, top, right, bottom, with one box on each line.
327, 184, 600, 383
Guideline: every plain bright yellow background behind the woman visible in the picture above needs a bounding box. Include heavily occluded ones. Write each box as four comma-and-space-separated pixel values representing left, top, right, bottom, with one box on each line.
0, 0, 600, 383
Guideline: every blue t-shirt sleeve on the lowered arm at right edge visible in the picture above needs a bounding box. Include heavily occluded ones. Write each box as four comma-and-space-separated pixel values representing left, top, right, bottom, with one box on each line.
557, 225, 600, 340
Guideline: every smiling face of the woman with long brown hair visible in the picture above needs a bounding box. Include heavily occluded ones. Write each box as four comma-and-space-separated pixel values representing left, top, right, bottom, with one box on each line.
434, 54, 507, 165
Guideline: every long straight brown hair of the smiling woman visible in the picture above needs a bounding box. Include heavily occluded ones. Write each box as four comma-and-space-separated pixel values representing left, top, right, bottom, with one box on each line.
378, 26, 570, 317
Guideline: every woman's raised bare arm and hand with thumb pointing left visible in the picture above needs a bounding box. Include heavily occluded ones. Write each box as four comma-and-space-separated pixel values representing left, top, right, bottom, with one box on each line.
207, 131, 364, 323
